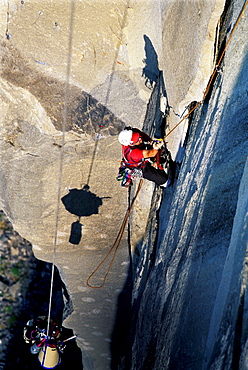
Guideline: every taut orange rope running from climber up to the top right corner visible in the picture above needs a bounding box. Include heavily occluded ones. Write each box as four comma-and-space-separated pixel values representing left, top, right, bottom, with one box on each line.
164, 1, 248, 140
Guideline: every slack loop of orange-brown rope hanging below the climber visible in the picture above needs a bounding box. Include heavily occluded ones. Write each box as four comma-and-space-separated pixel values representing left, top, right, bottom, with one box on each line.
86, 179, 143, 289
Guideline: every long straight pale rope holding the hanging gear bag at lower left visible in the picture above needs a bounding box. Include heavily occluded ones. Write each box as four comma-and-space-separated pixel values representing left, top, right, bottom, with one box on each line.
47, 0, 75, 336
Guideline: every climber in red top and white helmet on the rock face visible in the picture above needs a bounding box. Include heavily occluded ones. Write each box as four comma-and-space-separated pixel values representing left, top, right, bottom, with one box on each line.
118, 127, 169, 186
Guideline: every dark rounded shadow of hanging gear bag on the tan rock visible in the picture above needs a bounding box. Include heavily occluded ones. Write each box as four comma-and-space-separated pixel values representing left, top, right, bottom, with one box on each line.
61, 185, 110, 244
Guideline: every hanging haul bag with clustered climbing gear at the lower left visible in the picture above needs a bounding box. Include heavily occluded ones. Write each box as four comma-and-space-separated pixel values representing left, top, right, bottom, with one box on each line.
23, 316, 76, 369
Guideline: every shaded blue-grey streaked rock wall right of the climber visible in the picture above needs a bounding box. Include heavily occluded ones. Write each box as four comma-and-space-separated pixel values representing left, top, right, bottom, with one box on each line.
126, 1, 248, 370
